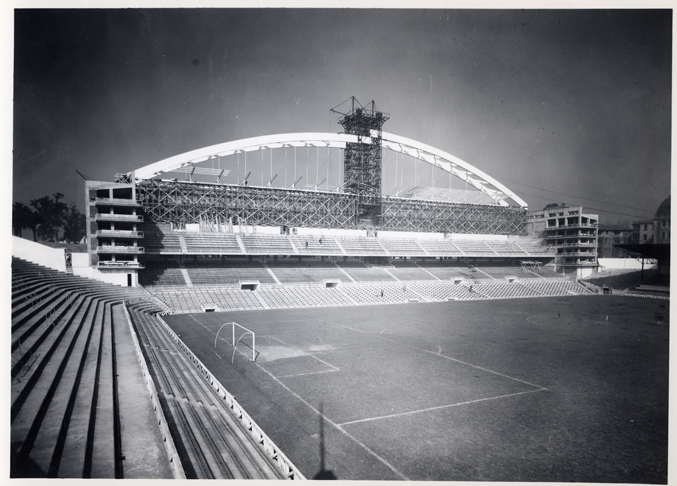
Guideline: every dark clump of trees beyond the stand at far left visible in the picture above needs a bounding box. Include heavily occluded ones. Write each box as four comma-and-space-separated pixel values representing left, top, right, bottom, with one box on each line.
12, 192, 86, 243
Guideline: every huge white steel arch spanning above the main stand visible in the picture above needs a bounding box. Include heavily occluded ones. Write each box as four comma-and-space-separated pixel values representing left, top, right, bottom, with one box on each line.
130, 132, 527, 208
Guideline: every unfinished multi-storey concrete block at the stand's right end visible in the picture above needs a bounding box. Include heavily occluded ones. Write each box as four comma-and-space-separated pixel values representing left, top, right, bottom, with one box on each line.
527, 206, 599, 278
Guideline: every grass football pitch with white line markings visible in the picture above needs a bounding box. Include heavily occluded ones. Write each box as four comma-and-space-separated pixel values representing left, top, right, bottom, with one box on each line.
165, 296, 669, 483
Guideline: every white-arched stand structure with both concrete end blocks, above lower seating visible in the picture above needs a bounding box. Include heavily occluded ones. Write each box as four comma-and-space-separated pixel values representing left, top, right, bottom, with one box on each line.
85, 98, 597, 286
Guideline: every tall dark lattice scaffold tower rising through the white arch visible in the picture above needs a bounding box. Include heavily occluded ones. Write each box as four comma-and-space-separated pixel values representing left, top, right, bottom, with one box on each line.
331, 96, 390, 226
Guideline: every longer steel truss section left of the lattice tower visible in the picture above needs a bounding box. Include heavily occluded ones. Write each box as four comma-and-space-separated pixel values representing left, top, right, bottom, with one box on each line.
137, 180, 357, 228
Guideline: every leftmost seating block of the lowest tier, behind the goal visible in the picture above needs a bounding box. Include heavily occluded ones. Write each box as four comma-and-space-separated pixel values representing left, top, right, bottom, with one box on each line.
152, 289, 263, 314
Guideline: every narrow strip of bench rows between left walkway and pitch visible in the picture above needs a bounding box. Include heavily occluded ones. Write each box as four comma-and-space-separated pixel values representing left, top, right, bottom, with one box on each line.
130, 311, 297, 479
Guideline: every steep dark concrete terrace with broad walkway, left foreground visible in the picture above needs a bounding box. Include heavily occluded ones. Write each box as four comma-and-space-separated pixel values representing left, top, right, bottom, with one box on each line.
10, 258, 172, 478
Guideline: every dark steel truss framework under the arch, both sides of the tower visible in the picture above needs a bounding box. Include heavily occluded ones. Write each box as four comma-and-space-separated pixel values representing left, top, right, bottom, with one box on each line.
137, 180, 526, 235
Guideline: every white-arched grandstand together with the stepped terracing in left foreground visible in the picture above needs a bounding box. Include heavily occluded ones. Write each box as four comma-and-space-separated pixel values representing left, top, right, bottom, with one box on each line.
11, 99, 616, 479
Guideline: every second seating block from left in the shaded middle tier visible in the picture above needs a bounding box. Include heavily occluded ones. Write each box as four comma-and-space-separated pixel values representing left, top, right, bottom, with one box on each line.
185, 260, 276, 285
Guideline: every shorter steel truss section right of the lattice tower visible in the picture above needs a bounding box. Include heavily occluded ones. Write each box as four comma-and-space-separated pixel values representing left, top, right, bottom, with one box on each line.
380, 198, 527, 236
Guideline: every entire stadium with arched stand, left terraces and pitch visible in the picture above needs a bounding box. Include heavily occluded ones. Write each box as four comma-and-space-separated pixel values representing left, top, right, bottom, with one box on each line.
11, 98, 668, 483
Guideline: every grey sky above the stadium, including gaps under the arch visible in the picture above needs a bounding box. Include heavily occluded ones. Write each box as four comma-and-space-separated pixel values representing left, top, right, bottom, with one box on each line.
12, 8, 672, 223
